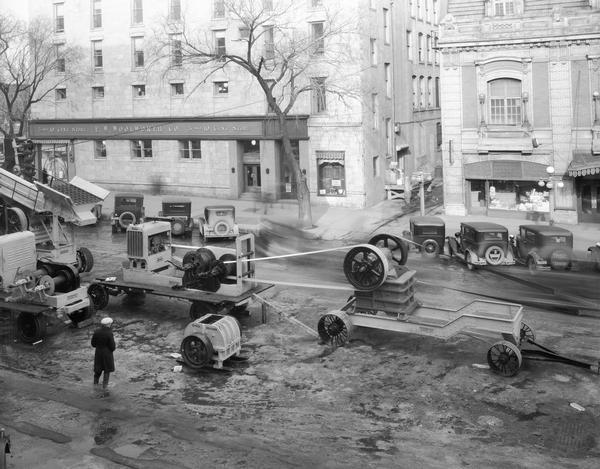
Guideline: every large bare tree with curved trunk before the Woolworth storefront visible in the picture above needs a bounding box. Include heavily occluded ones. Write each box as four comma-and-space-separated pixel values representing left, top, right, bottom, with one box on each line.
152, 0, 359, 228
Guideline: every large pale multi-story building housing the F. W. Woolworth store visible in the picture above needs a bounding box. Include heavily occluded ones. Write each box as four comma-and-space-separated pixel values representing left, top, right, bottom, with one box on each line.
7, 0, 442, 207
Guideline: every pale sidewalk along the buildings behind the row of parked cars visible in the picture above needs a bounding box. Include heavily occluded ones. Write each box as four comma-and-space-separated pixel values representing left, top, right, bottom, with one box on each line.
102, 192, 600, 253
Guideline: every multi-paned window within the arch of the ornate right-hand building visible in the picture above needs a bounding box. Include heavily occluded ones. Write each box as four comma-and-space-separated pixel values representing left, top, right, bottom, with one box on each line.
488, 78, 521, 125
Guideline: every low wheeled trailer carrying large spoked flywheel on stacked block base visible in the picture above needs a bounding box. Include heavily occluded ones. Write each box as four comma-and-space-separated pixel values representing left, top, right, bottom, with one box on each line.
318, 244, 598, 376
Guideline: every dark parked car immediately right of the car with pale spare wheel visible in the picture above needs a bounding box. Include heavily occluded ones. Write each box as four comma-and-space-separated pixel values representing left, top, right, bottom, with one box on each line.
511, 225, 573, 272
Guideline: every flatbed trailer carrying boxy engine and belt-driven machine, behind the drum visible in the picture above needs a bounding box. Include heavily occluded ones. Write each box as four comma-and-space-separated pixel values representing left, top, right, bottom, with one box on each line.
88, 221, 272, 320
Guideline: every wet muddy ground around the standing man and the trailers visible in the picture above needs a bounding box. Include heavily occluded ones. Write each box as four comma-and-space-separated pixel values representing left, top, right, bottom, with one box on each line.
0, 226, 600, 469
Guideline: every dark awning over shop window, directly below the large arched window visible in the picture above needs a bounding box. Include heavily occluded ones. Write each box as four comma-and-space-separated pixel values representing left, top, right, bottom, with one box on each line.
464, 160, 548, 181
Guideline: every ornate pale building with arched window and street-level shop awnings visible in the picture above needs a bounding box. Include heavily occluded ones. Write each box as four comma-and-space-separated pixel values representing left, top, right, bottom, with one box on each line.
439, 0, 600, 223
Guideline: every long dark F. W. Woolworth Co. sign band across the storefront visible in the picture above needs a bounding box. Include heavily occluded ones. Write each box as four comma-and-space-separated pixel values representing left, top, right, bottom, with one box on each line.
29, 116, 308, 140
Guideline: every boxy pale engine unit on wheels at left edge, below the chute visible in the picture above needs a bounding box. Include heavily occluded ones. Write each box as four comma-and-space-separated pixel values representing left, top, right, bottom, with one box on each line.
0, 231, 94, 343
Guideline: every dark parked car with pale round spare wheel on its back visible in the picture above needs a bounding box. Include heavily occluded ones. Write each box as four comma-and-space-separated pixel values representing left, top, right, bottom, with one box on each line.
448, 221, 515, 270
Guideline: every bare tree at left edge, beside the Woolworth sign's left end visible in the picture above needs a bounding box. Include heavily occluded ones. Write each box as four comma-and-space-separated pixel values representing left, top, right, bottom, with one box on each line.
0, 16, 83, 170
